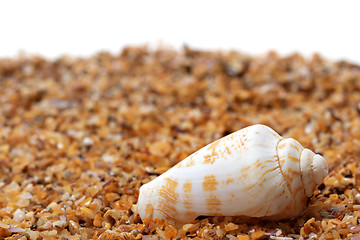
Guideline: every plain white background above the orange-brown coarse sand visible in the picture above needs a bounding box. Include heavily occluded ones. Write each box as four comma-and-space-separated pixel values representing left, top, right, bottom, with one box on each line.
0, 0, 360, 64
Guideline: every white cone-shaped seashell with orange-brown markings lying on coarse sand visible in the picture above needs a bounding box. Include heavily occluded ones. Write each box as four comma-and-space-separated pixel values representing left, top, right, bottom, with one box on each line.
138, 124, 328, 226
